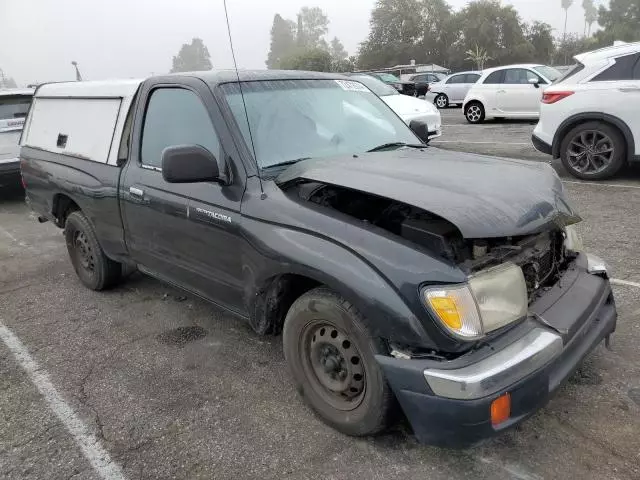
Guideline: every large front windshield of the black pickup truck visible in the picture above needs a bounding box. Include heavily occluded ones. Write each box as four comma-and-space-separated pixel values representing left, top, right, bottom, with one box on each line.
222, 80, 419, 168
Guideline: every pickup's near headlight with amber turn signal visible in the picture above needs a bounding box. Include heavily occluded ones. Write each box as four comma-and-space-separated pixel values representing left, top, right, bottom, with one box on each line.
423, 263, 529, 340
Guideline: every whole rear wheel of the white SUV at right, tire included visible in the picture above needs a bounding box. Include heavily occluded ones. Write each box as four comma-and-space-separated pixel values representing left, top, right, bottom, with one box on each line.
560, 121, 627, 180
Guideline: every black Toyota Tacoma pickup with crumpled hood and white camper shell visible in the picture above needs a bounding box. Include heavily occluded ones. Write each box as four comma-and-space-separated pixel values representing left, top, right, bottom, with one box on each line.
20, 71, 616, 446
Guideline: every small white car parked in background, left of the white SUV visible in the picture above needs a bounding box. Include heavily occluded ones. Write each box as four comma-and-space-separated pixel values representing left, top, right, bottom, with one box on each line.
463, 64, 560, 123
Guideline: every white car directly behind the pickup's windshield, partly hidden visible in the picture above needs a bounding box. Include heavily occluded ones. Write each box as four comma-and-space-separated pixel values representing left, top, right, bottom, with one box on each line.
350, 74, 442, 140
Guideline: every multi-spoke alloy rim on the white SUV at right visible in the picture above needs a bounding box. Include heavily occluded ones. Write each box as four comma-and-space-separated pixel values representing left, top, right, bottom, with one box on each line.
567, 130, 616, 175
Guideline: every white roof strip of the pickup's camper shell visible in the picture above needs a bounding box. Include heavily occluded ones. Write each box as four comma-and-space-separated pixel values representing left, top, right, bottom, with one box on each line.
35, 79, 143, 98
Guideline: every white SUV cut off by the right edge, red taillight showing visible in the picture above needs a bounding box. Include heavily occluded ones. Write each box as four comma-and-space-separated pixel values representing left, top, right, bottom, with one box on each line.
532, 42, 640, 180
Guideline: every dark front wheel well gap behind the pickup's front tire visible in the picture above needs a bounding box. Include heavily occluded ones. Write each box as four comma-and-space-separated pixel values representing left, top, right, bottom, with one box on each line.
250, 273, 321, 335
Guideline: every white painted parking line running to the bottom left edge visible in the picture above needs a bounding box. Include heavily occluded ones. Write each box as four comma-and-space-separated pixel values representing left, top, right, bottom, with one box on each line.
0, 321, 126, 480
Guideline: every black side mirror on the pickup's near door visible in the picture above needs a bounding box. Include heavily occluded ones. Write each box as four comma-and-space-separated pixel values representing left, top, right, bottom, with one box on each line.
162, 145, 221, 183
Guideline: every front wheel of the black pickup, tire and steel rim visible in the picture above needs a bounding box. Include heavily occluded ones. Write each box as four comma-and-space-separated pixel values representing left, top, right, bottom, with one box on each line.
283, 287, 394, 436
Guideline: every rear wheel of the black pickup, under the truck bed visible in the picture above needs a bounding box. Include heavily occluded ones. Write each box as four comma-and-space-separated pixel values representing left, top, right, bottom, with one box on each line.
64, 210, 122, 290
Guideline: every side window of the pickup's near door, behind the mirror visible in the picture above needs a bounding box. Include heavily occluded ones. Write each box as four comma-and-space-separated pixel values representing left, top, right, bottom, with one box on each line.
140, 88, 220, 168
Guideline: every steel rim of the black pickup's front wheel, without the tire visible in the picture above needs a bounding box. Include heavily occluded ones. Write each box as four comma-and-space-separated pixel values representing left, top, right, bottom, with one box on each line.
300, 320, 367, 411
